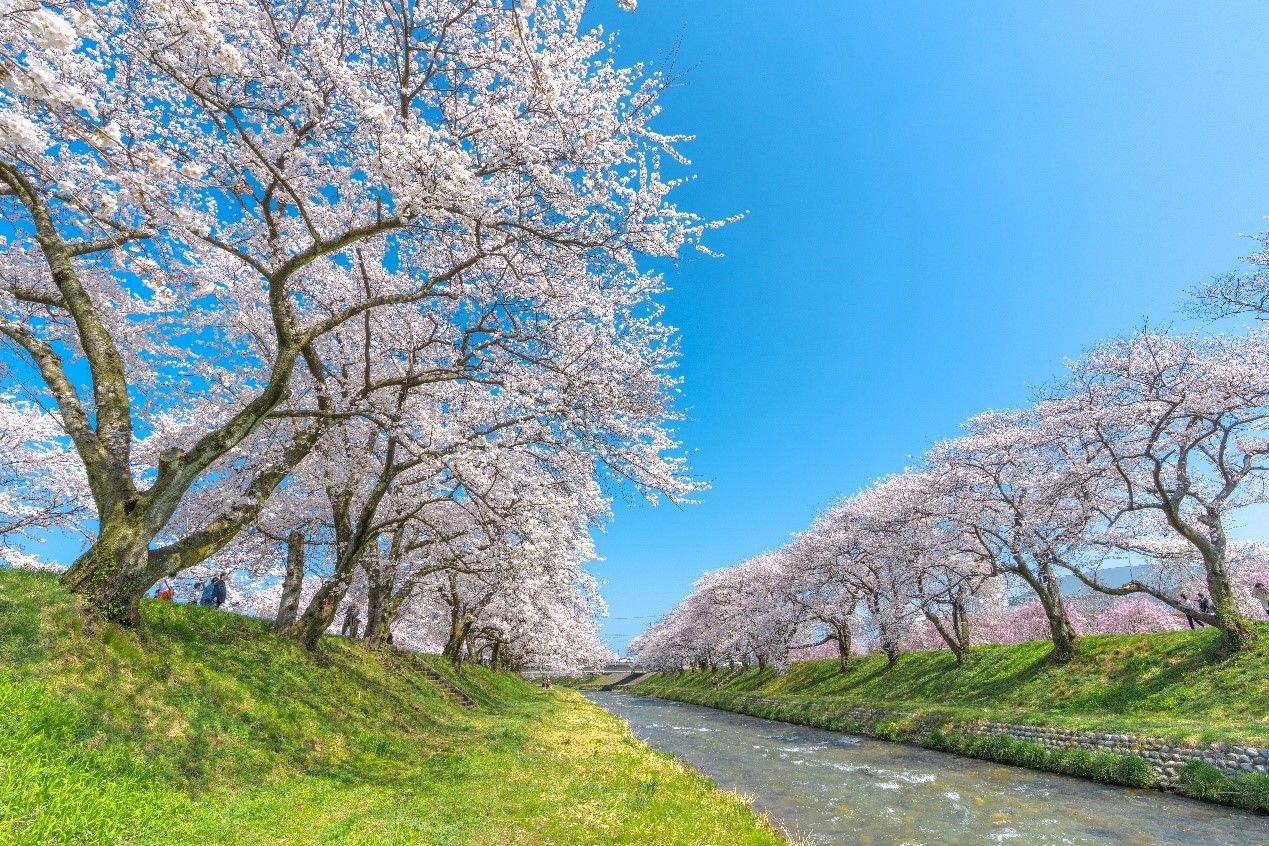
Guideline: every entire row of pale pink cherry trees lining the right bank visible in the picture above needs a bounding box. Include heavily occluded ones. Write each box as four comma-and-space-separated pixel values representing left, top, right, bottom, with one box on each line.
632, 267, 1269, 667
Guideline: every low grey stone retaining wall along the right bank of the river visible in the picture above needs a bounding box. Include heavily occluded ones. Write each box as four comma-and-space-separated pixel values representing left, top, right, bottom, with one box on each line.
710, 696, 1269, 790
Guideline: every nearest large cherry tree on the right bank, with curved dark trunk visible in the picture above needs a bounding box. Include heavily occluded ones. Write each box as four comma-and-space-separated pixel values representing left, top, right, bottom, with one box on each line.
1038, 330, 1269, 647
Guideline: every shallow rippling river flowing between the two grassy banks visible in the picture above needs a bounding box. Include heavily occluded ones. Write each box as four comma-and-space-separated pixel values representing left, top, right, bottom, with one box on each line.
588, 693, 1269, 846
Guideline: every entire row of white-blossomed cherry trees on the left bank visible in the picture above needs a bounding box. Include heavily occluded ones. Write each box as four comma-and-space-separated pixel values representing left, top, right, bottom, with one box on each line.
0, 0, 695, 663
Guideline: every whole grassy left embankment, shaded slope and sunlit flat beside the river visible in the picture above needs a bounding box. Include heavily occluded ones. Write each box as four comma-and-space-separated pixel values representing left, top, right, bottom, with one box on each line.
0, 571, 783, 846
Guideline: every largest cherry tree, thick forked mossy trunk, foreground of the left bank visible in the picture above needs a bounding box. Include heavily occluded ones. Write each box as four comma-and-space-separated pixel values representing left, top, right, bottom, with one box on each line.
0, 0, 707, 621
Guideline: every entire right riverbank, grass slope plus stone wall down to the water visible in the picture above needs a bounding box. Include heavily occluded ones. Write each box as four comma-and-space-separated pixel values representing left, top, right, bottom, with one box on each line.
631, 627, 1269, 810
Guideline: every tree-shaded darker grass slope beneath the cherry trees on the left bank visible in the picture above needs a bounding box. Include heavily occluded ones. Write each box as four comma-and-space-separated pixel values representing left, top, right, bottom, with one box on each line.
0, 571, 525, 793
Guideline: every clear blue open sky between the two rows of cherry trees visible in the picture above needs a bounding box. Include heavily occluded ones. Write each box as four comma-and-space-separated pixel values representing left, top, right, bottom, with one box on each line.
589, 0, 1269, 651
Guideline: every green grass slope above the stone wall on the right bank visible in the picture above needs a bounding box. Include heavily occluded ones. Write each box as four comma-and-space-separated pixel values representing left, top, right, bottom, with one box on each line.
635, 624, 1269, 746
